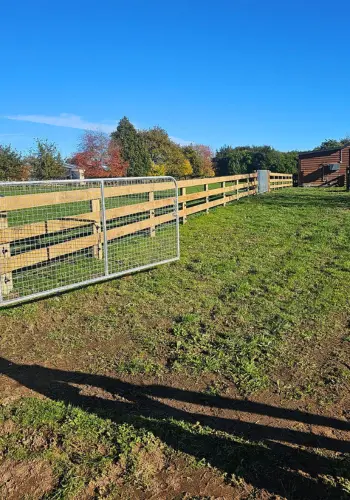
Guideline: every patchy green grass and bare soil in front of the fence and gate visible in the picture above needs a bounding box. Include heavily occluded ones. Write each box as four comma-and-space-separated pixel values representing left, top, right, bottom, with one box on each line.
0, 189, 350, 499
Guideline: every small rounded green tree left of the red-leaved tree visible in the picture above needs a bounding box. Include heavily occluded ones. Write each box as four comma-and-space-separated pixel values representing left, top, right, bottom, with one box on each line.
27, 139, 66, 180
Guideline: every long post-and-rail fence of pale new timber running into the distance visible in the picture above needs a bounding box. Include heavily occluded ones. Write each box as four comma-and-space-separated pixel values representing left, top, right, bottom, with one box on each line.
0, 172, 292, 299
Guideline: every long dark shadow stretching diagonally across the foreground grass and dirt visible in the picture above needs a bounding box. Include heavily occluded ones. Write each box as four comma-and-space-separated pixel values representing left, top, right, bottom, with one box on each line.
0, 358, 350, 499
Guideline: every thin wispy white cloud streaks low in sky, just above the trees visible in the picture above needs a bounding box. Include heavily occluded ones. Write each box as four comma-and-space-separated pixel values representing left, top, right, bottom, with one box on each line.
4, 113, 191, 146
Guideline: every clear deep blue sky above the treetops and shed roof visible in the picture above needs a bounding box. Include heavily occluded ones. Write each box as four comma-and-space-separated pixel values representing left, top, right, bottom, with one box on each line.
0, 0, 350, 155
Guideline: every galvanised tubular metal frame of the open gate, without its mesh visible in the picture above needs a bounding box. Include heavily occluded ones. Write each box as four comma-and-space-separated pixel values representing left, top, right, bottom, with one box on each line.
0, 176, 180, 308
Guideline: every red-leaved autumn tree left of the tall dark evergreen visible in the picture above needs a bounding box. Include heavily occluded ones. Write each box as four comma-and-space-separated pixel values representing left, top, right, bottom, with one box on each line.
70, 130, 129, 178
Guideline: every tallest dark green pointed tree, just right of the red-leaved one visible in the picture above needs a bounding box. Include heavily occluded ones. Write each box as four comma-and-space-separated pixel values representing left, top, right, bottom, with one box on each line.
111, 116, 152, 177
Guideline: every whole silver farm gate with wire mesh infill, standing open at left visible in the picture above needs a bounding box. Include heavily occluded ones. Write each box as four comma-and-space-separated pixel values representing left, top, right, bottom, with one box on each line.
0, 177, 180, 307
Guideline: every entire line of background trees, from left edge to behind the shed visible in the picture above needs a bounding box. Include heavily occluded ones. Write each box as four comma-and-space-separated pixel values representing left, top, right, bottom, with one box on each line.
0, 117, 350, 181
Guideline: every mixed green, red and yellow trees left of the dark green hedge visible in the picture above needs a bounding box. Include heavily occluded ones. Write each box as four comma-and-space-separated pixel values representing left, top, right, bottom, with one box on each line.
0, 117, 215, 181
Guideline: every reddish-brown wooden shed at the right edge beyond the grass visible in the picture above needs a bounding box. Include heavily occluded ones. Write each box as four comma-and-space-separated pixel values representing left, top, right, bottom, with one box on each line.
298, 144, 350, 186
